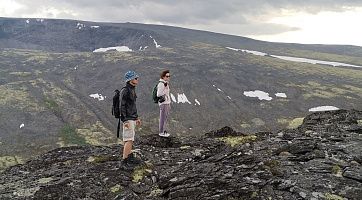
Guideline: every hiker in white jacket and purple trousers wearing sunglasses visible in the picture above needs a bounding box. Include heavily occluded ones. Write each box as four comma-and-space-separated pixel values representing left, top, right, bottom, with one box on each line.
157, 70, 171, 137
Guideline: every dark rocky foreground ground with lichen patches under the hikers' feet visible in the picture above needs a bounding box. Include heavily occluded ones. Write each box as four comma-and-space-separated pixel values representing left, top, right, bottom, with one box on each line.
0, 110, 362, 200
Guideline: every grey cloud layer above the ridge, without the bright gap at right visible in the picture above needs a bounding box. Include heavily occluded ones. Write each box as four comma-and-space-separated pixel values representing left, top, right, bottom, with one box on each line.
0, 0, 362, 35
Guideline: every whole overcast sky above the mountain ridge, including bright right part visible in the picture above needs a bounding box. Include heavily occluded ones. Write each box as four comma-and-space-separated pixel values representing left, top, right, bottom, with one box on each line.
0, 0, 362, 46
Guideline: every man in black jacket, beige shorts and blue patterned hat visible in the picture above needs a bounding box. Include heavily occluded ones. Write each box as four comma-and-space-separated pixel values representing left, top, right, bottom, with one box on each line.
120, 71, 141, 165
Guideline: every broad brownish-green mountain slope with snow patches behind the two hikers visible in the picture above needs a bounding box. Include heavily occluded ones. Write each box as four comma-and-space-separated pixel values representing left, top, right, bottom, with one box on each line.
0, 18, 362, 168
